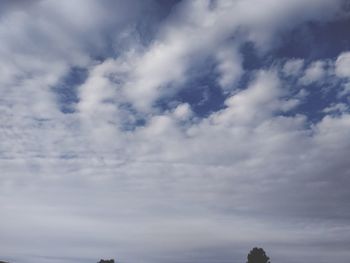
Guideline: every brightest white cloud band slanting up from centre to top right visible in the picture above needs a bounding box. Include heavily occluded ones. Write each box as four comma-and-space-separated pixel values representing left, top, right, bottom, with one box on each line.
78, 0, 339, 112
